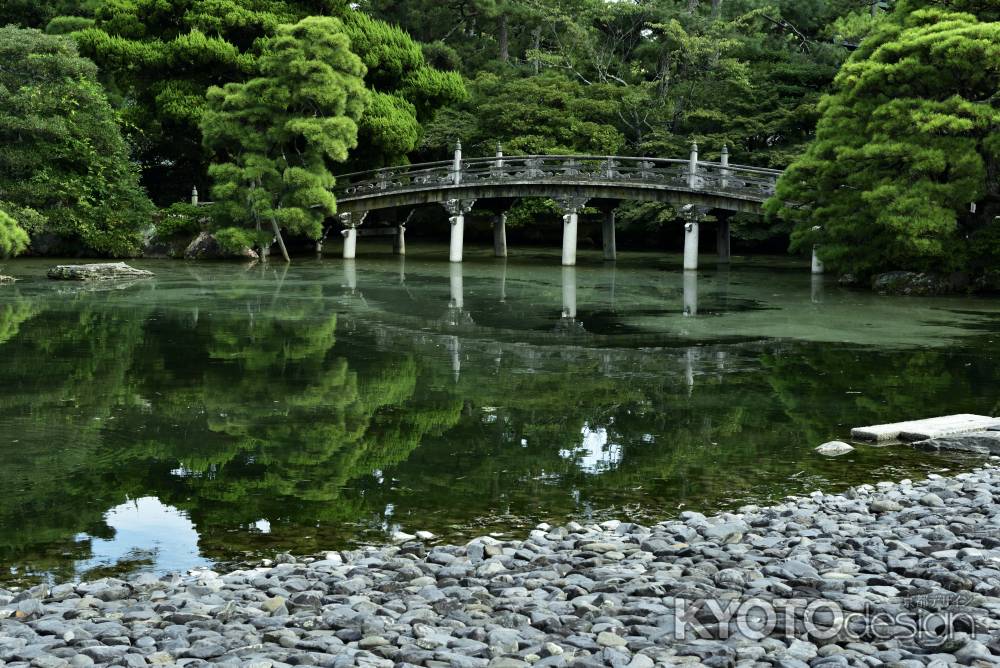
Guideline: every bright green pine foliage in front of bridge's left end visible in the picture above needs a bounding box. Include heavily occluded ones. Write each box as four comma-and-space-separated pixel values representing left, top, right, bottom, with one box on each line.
202, 17, 369, 239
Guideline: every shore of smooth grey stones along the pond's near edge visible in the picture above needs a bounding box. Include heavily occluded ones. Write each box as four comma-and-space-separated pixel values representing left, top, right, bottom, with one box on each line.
0, 458, 1000, 668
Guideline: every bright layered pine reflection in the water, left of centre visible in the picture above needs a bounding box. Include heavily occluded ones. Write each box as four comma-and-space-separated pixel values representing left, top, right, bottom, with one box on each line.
107, 286, 460, 556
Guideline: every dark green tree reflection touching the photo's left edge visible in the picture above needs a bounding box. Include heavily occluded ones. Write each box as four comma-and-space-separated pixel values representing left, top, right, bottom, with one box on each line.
0, 294, 150, 574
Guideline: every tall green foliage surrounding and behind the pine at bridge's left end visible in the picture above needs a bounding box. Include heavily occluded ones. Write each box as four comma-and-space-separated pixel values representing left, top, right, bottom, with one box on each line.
67, 0, 465, 204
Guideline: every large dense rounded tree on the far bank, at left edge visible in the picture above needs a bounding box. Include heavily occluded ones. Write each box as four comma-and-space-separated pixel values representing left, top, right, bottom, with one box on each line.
0, 27, 151, 256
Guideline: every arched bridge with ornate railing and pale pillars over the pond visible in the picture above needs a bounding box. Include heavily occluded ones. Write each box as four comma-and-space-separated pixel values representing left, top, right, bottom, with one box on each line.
334, 144, 781, 269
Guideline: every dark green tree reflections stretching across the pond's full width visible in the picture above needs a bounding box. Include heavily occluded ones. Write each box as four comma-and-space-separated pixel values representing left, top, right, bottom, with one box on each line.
0, 276, 997, 575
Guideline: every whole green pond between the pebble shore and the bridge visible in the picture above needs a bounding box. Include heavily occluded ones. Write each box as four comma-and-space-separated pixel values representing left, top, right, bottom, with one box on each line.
0, 246, 1000, 584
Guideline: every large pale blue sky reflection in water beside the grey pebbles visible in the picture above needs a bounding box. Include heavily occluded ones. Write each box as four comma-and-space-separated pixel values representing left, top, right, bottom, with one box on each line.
77, 497, 211, 573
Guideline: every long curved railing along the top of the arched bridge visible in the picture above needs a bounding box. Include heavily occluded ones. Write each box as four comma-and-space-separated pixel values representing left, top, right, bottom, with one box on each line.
334, 155, 781, 199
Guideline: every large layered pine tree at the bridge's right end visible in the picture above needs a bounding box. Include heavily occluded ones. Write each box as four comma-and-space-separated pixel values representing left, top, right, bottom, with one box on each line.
768, 3, 1000, 275
